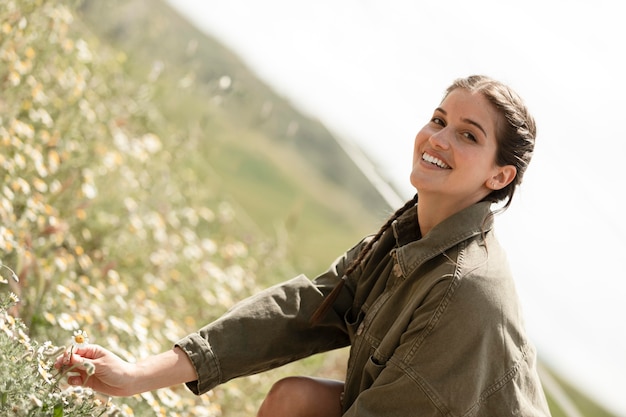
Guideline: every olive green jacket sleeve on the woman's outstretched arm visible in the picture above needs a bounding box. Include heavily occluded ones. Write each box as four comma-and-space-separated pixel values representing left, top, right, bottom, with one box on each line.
176, 239, 368, 394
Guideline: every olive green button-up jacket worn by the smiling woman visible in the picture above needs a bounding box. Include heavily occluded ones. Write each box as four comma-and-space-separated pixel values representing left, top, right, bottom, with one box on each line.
177, 203, 550, 417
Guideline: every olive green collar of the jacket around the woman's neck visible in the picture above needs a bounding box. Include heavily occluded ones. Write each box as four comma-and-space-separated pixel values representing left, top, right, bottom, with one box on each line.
392, 201, 493, 276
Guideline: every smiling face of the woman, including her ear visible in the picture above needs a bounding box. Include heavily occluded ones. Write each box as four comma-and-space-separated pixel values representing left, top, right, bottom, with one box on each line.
411, 88, 516, 211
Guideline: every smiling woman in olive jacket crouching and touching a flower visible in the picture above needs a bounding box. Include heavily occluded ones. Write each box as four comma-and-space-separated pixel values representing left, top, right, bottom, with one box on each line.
57, 76, 550, 417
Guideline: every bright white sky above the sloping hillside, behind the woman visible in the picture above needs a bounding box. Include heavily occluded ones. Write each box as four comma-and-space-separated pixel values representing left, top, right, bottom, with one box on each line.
163, 0, 626, 417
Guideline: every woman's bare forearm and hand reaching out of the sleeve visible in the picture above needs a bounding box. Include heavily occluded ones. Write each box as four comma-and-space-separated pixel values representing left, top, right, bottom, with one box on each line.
55, 345, 197, 396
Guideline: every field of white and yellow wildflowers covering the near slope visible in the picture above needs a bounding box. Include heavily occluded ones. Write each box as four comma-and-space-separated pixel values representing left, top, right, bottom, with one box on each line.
0, 0, 356, 416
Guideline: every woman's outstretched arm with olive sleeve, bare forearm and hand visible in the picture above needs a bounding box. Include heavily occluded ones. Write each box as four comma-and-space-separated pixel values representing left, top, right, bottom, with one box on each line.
55, 242, 357, 396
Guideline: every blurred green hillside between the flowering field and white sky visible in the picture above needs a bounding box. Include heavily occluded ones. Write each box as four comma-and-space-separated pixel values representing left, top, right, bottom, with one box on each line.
74, 0, 400, 273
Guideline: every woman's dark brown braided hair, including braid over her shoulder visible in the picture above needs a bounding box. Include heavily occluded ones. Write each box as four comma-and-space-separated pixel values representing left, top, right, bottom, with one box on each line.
311, 75, 536, 323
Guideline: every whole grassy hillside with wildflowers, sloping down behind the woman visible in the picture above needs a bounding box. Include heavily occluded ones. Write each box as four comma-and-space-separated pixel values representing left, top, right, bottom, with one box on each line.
0, 0, 609, 417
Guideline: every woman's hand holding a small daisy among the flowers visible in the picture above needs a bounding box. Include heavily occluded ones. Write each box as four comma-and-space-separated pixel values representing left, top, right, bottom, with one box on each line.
54, 345, 136, 396
